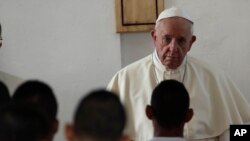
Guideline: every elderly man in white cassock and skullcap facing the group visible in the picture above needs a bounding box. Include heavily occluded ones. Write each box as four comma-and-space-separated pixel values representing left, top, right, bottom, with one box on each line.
108, 7, 250, 141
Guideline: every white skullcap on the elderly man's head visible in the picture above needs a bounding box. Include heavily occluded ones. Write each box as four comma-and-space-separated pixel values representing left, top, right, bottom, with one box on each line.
155, 7, 193, 23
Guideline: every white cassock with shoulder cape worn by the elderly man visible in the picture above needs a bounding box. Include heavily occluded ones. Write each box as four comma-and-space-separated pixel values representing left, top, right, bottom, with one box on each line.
108, 52, 250, 141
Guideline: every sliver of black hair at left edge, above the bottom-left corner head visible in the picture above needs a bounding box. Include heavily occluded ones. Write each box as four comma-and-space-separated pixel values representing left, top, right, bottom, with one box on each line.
0, 81, 10, 108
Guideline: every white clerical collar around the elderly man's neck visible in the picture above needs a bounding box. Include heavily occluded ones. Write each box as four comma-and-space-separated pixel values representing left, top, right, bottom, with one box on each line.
153, 50, 187, 74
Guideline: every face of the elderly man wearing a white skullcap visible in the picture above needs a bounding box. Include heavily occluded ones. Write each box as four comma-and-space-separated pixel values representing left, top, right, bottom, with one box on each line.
151, 17, 196, 69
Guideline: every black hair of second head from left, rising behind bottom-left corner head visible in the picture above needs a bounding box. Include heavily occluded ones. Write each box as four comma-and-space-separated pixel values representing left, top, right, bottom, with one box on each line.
12, 80, 58, 122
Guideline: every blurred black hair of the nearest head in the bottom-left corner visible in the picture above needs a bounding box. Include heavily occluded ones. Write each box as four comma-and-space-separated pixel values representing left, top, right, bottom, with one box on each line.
0, 103, 49, 141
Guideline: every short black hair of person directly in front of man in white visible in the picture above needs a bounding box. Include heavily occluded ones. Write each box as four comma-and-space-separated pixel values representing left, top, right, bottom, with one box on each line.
151, 80, 190, 129
